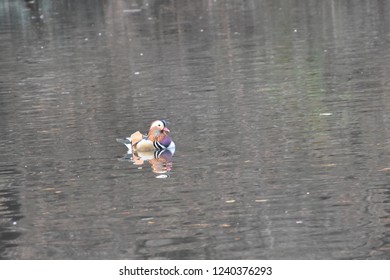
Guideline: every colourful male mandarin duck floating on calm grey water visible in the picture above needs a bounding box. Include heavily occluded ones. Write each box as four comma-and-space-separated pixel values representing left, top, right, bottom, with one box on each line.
117, 120, 175, 152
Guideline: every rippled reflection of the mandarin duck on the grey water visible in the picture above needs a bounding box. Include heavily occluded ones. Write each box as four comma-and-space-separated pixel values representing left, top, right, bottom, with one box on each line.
118, 149, 175, 178
